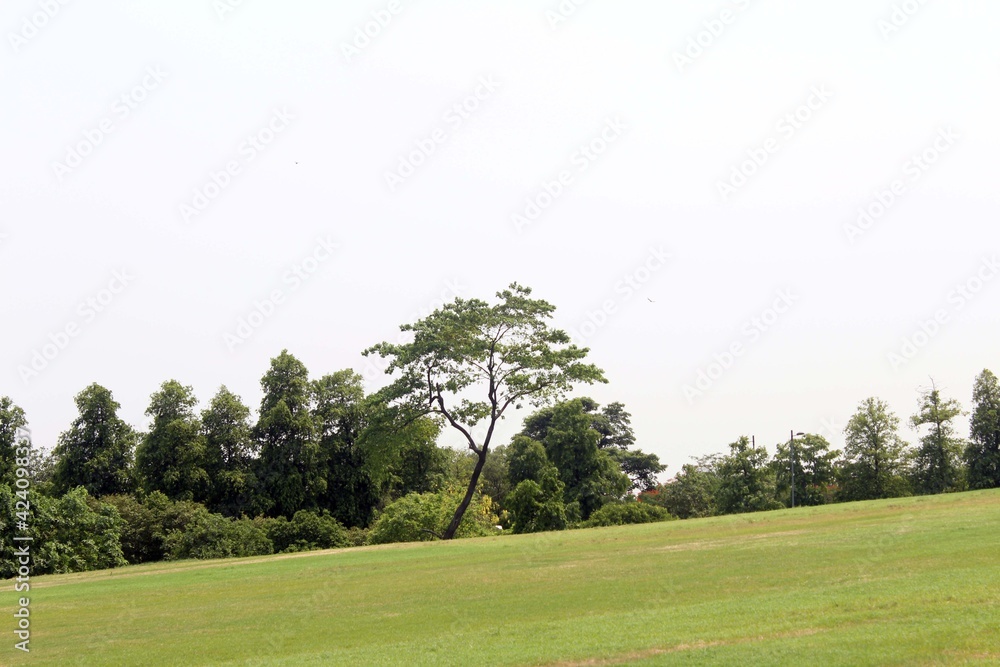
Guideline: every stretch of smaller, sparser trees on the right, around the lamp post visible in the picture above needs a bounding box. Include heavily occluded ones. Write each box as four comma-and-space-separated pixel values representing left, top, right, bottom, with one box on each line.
639, 370, 1000, 519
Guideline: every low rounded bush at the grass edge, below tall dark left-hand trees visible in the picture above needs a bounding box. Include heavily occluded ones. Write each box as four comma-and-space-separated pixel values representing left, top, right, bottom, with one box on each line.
164, 503, 274, 560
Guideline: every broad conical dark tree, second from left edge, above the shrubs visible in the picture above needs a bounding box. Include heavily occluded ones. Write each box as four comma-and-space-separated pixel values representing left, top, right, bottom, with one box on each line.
52, 384, 137, 497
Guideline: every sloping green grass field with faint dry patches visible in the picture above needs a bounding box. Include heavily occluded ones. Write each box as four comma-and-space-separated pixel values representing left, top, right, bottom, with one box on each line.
0, 490, 1000, 666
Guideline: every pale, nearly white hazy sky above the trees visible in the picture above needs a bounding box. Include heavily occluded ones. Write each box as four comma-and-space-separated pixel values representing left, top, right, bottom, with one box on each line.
0, 0, 1000, 476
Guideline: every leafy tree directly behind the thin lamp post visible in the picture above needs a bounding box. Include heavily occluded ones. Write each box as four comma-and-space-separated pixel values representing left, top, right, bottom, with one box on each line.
773, 433, 840, 505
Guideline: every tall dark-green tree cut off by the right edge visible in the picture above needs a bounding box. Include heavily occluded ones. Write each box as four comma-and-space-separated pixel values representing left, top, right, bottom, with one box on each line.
965, 370, 1000, 489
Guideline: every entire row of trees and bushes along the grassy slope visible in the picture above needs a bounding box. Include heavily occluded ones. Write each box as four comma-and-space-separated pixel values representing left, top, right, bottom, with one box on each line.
0, 284, 1000, 577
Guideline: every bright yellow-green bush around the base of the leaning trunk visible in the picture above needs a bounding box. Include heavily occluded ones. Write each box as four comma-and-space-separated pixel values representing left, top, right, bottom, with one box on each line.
368, 492, 497, 544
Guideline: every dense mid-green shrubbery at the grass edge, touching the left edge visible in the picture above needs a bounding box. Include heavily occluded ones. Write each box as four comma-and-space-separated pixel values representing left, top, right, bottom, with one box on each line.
0, 484, 127, 578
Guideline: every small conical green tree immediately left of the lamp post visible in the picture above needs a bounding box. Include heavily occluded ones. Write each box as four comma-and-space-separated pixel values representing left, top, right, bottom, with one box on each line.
716, 435, 781, 514
